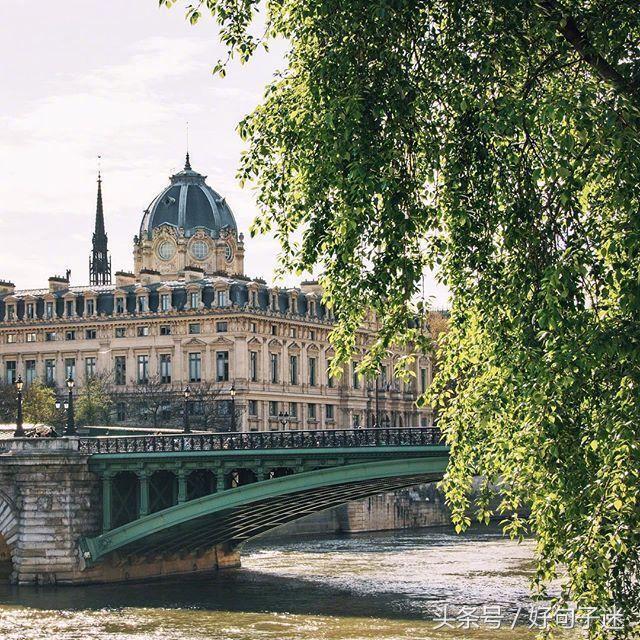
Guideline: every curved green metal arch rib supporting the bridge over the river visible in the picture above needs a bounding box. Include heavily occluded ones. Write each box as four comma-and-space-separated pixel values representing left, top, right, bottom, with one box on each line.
80, 456, 448, 564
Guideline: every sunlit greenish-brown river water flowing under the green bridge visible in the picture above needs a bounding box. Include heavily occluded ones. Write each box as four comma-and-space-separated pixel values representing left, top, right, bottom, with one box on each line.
0, 529, 576, 640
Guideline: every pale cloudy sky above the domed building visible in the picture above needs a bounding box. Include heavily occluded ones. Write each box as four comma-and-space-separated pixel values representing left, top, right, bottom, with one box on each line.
0, 0, 446, 306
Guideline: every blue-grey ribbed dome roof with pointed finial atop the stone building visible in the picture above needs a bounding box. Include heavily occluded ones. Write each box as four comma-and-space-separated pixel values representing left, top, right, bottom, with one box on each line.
140, 154, 238, 238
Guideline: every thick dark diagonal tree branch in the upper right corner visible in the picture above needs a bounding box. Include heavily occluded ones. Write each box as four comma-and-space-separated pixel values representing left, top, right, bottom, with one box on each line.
536, 0, 640, 109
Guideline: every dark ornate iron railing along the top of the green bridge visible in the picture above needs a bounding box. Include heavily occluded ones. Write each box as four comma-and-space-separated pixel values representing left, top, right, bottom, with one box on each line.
79, 427, 444, 454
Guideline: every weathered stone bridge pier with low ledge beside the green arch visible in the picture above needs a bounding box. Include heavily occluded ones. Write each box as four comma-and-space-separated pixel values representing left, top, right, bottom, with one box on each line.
0, 438, 239, 584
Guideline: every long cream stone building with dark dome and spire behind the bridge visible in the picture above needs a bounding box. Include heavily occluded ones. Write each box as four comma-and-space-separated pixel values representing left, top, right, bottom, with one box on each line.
0, 154, 432, 431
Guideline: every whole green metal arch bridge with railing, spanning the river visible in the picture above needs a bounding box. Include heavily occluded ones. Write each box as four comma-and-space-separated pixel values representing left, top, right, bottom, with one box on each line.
78, 428, 448, 566
